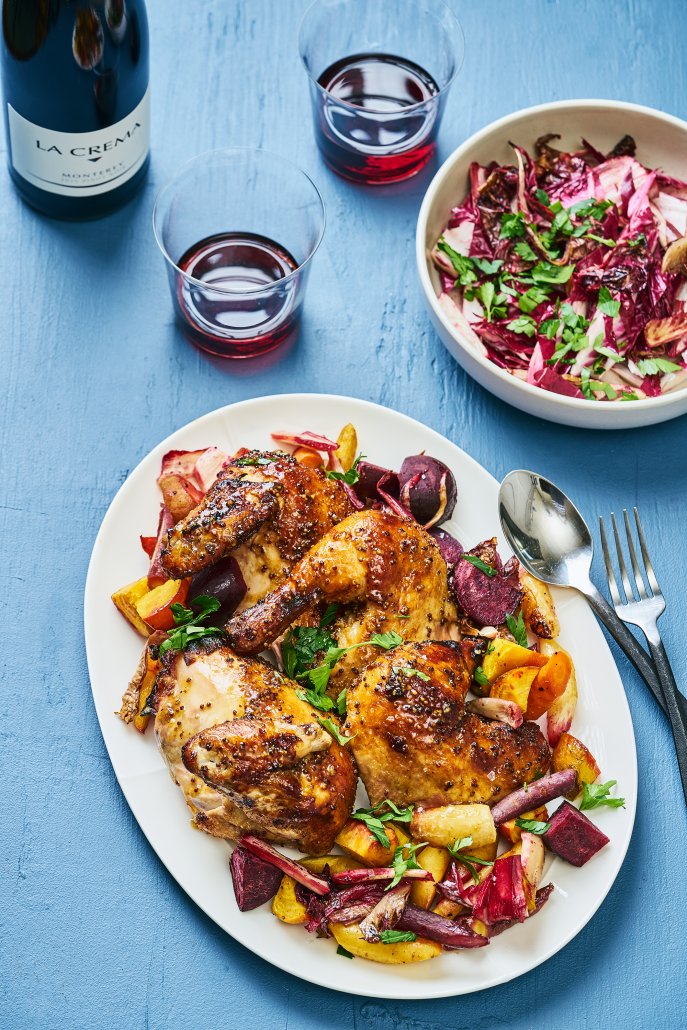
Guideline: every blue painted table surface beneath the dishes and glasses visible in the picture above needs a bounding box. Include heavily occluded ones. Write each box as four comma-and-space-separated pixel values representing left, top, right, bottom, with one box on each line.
0, 0, 687, 1030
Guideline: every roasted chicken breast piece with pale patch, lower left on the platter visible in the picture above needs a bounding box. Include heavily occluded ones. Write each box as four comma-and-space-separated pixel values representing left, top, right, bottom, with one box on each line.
150, 640, 357, 855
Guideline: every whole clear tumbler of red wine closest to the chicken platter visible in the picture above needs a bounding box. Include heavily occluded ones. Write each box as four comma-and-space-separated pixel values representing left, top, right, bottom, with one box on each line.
152, 148, 324, 357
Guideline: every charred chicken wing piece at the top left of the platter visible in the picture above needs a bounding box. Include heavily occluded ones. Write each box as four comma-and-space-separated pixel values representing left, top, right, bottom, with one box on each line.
161, 451, 352, 607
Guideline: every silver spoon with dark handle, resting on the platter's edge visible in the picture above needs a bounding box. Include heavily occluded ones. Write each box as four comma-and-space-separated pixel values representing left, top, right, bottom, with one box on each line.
499, 469, 687, 717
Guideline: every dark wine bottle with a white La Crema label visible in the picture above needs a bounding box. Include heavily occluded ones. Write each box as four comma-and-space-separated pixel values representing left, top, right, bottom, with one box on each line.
2, 0, 149, 218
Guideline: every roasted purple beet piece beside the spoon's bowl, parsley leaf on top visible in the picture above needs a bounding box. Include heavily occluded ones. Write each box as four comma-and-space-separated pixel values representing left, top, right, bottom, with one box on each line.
451, 540, 521, 626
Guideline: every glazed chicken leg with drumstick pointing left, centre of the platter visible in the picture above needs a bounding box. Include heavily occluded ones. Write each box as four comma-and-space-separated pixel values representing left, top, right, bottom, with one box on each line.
227, 511, 451, 696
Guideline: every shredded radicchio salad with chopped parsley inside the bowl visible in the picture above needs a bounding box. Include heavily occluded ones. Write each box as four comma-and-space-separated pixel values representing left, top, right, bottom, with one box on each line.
432, 134, 687, 402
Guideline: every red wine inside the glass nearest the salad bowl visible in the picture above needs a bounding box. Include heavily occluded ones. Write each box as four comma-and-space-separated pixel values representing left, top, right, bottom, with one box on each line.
315, 53, 439, 183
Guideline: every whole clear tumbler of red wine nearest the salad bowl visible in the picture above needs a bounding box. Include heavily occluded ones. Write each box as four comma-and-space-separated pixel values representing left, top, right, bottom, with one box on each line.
299, 0, 465, 185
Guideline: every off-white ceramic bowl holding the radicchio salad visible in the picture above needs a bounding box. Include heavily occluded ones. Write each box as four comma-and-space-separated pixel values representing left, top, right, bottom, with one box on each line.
416, 100, 687, 430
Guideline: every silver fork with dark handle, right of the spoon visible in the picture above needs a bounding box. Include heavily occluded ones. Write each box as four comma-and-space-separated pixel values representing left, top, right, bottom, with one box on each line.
598, 508, 687, 801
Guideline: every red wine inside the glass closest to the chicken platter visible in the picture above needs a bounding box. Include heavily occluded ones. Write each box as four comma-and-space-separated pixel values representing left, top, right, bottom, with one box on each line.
175, 233, 299, 357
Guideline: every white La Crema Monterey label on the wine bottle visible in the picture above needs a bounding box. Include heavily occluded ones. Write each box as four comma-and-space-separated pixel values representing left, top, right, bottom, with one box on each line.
7, 88, 150, 197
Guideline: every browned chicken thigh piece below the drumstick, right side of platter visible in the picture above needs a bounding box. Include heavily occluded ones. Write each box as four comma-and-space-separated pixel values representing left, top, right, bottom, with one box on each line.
345, 642, 550, 805
